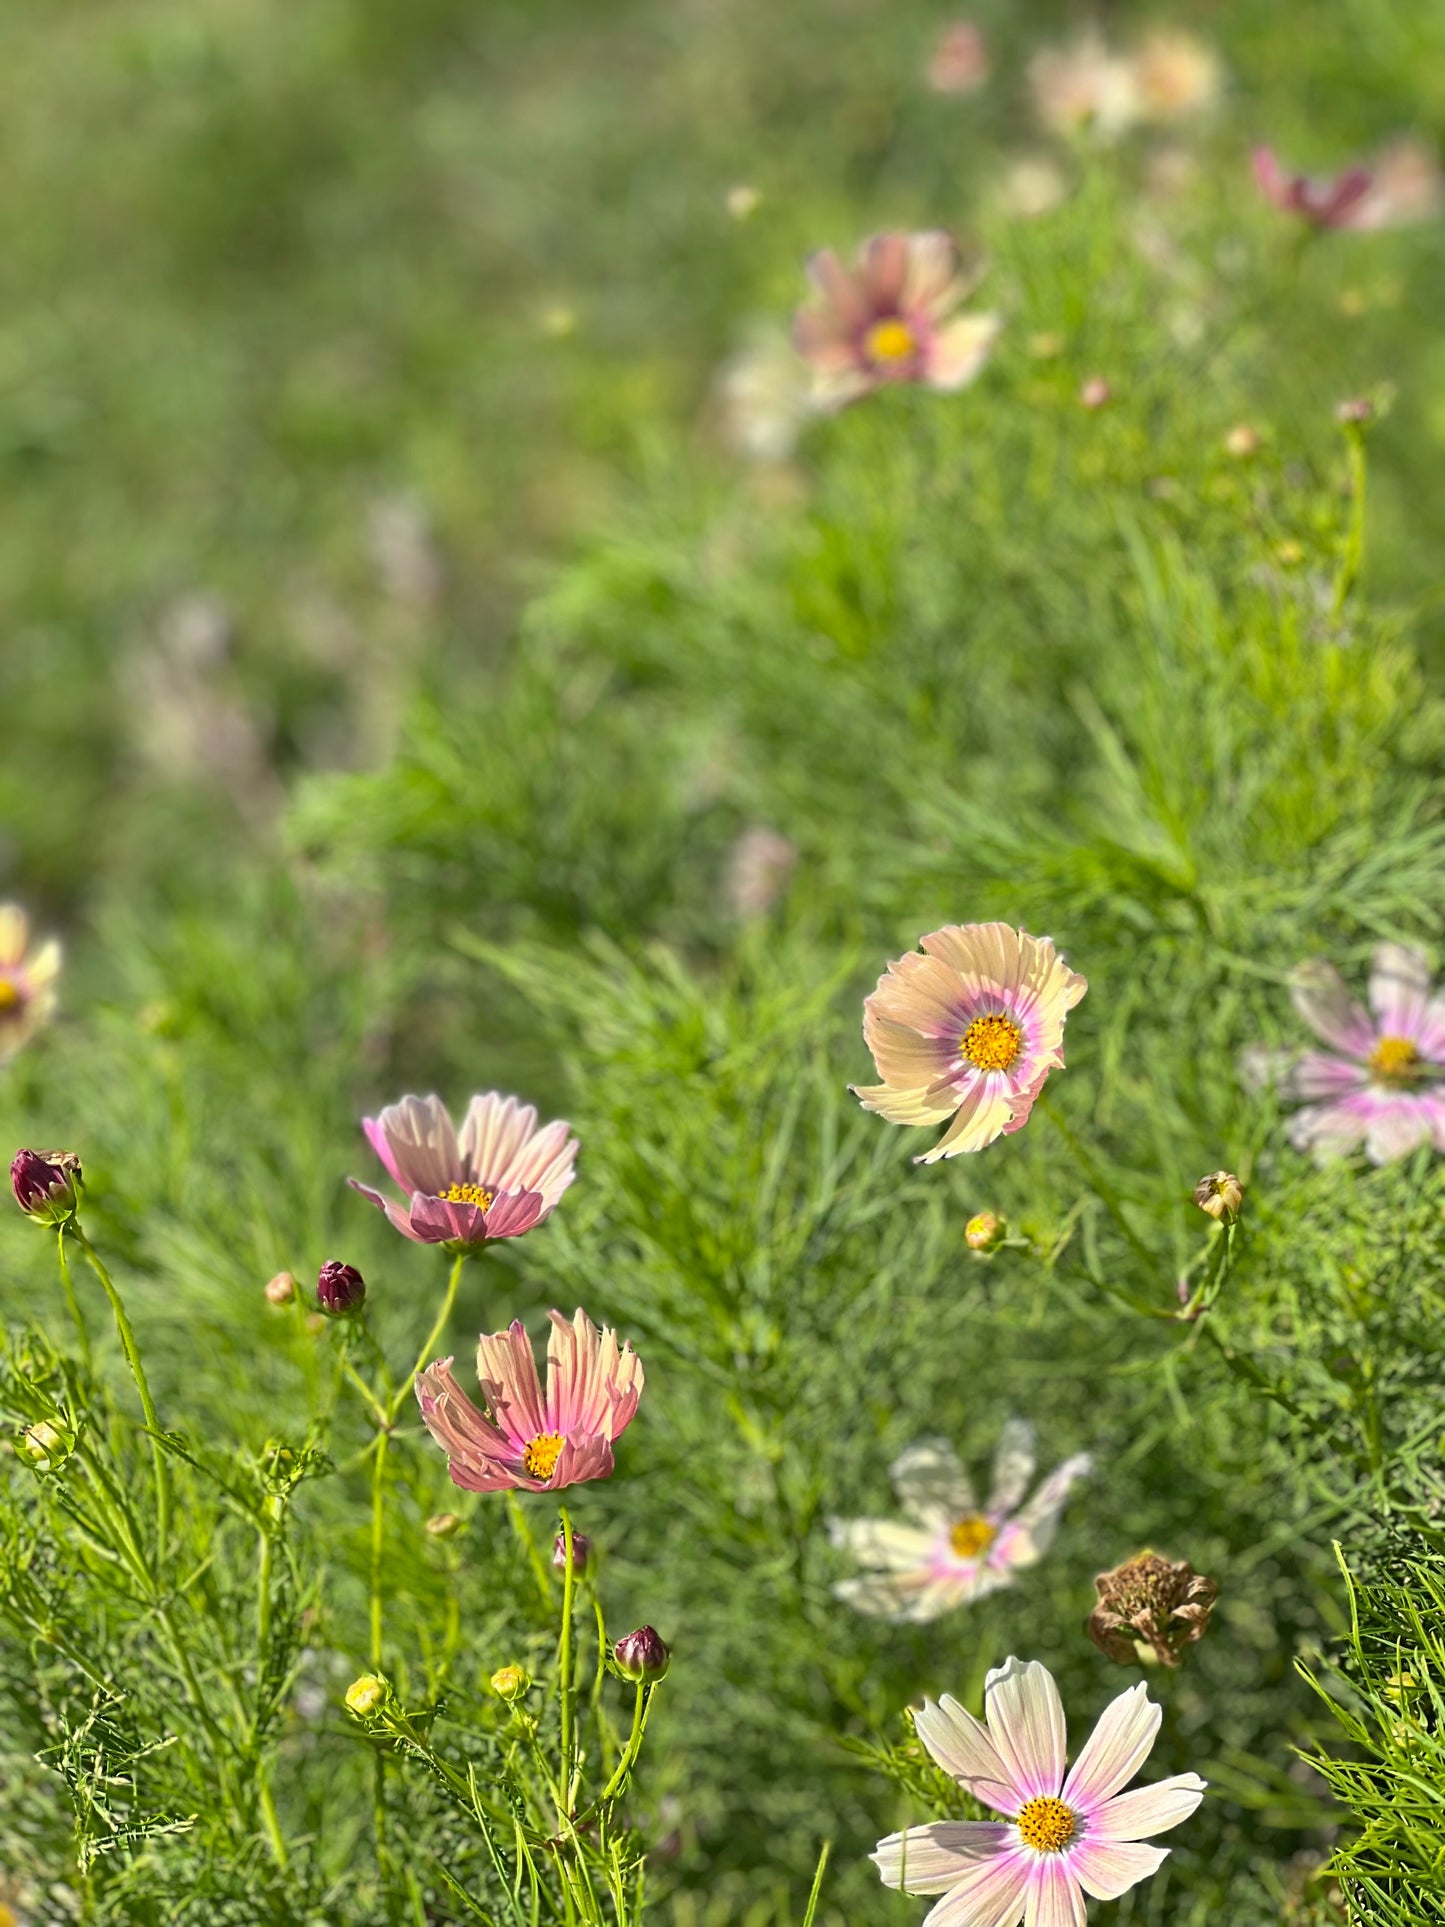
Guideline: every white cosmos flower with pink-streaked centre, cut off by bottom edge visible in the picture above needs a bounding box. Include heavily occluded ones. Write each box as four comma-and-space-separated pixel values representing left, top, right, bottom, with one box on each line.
873, 1659, 1204, 1927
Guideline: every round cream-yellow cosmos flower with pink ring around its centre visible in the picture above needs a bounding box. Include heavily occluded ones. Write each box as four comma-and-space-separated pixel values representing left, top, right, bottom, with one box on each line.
850, 923, 1089, 1164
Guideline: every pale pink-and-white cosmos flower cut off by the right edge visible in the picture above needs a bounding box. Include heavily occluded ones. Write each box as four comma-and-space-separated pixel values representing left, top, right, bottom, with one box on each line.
1245, 944, 1445, 1164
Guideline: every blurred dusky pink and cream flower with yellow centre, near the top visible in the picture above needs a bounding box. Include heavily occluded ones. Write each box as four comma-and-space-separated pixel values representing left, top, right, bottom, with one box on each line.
794, 229, 1000, 412
